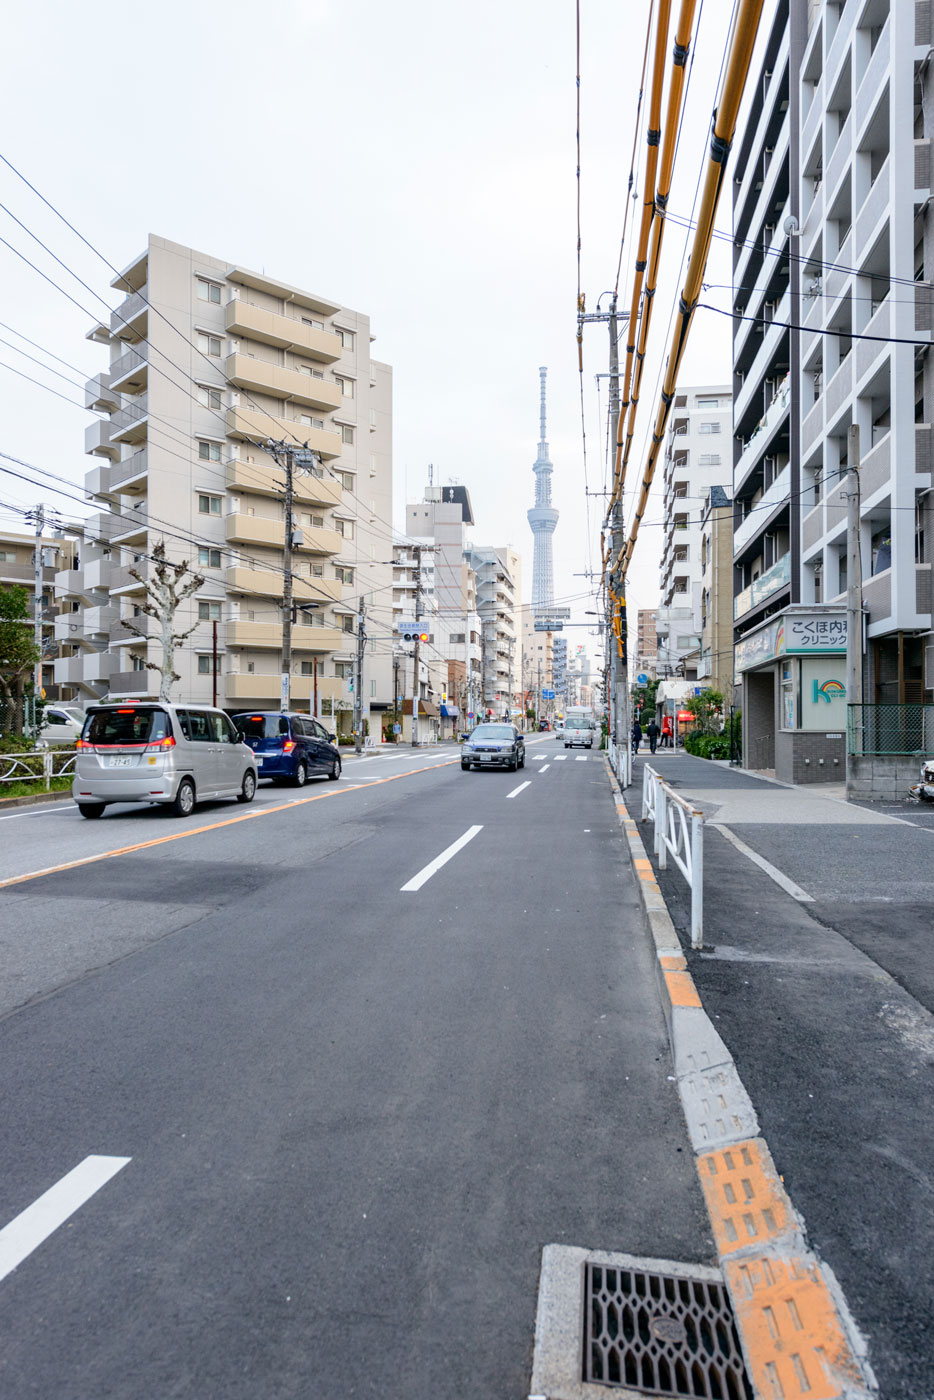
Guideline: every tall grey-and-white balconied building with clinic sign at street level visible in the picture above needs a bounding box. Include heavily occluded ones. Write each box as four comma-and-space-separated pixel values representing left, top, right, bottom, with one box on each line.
734, 0, 934, 781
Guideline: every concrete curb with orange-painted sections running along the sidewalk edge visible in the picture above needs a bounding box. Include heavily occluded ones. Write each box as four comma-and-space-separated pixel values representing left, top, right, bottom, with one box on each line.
606, 763, 877, 1400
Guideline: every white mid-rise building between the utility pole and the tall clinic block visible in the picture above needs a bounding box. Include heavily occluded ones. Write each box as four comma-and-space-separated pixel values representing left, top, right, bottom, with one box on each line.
655, 384, 732, 676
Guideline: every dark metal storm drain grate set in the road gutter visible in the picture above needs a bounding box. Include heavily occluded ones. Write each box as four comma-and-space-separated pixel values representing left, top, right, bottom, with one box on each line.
584, 1263, 752, 1400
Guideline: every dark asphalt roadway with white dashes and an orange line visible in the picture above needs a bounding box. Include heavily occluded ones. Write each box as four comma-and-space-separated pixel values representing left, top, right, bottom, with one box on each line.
0, 736, 713, 1400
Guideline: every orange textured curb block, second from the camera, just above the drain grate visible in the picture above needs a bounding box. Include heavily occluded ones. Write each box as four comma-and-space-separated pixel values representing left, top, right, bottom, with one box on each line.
697, 1136, 797, 1254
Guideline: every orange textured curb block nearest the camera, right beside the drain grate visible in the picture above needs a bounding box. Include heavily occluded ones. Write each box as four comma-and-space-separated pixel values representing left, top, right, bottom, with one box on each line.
724, 1254, 867, 1400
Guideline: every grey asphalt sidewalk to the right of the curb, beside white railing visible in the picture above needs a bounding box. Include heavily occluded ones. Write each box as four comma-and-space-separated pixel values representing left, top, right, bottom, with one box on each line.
626, 752, 934, 1400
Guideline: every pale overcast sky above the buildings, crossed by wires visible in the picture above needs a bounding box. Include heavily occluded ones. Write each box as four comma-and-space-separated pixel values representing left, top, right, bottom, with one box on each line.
0, 0, 772, 647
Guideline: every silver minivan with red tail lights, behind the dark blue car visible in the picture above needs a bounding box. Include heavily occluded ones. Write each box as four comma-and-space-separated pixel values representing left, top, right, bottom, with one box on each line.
71, 700, 256, 818
